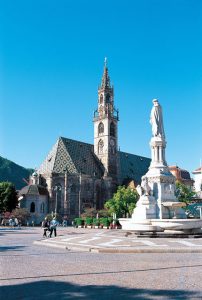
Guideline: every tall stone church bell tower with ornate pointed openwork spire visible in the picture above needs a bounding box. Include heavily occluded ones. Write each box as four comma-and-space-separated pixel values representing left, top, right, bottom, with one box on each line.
94, 58, 119, 180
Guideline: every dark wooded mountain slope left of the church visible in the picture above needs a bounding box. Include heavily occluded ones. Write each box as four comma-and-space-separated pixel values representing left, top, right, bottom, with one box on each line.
0, 156, 34, 190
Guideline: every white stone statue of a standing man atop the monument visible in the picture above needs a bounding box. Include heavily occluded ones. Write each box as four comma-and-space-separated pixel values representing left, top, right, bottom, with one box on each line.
150, 99, 165, 138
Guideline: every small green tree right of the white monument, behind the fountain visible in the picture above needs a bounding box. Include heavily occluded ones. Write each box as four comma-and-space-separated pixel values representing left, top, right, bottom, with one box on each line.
176, 181, 196, 205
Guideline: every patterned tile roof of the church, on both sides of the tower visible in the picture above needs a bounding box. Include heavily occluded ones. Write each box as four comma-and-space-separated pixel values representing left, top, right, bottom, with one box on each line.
38, 137, 150, 183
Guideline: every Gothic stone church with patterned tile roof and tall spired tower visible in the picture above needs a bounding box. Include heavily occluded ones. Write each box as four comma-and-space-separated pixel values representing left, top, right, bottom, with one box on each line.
20, 61, 150, 221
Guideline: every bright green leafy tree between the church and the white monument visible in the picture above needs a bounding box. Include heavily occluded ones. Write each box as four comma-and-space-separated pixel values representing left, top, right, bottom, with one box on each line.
105, 186, 138, 218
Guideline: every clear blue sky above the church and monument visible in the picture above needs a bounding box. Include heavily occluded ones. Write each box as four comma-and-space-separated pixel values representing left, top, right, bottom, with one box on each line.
0, 0, 202, 171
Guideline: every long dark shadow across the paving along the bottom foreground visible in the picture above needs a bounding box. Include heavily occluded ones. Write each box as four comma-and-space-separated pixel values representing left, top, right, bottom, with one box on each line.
0, 281, 202, 300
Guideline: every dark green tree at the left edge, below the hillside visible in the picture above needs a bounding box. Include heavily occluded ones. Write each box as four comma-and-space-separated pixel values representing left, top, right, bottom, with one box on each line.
0, 182, 18, 212
